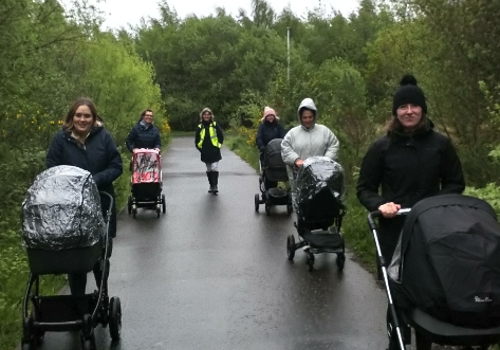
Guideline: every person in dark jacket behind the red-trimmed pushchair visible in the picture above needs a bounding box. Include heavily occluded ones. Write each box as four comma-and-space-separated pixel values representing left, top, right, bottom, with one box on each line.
125, 109, 161, 152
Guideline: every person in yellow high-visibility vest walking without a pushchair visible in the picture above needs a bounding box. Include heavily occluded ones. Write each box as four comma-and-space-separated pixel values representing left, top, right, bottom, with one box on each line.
194, 108, 224, 194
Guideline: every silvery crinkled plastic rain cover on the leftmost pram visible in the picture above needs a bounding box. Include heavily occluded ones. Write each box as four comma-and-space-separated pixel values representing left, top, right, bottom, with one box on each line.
22, 165, 105, 251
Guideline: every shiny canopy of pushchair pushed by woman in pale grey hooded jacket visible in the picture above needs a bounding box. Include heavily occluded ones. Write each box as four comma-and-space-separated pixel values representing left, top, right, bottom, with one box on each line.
295, 156, 345, 205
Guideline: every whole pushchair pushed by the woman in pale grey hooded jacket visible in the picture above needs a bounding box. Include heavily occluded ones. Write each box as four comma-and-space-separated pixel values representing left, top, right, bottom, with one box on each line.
286, 157, 346, 270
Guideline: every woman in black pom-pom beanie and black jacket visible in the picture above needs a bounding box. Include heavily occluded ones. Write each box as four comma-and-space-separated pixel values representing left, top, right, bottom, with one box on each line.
356, 75, 465, 350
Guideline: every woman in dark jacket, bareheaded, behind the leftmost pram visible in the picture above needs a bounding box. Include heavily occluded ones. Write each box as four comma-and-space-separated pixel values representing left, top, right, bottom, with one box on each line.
46, 98, 123, 295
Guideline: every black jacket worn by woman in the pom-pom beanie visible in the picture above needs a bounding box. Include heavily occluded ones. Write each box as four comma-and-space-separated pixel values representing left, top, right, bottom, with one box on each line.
356, 128, 465, 211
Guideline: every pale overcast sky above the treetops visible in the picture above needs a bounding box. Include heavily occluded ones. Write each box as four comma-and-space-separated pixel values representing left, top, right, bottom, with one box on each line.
62, 0, 359, 29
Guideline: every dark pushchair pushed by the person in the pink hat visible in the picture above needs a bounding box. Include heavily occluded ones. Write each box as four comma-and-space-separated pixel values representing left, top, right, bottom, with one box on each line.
255, 139, 293, 215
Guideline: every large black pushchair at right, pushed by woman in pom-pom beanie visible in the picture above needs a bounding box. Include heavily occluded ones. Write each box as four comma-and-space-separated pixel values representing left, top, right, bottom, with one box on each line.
368, 194, 500, 350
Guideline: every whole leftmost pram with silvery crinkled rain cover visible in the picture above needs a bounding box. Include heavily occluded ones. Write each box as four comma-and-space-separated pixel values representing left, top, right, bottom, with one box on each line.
22, 166, 122, 350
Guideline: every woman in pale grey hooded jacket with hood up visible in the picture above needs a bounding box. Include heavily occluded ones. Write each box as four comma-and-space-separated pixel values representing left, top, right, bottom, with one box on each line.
281, 98, 339, 205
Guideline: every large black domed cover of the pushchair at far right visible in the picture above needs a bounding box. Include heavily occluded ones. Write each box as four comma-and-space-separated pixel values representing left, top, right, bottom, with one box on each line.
389, 194, 500, 328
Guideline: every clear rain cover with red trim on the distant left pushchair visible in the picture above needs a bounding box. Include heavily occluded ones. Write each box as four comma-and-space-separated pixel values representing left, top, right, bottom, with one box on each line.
132, 149, 161, 185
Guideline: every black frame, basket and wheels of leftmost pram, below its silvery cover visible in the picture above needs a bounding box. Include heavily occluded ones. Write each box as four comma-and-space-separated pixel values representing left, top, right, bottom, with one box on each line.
21, 192, 122, 350
